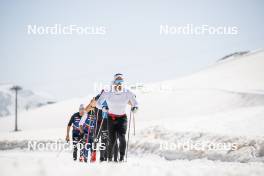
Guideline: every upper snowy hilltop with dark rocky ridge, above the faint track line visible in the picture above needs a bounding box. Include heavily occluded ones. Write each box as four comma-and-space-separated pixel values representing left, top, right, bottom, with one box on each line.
155, 50, 264, 93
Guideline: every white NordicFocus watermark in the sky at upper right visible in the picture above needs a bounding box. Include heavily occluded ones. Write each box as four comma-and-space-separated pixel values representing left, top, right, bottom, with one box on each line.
159, 24, 239, 35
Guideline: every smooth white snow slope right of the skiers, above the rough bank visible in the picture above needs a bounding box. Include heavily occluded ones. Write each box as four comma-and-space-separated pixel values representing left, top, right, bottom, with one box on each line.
136, 50, 264, 133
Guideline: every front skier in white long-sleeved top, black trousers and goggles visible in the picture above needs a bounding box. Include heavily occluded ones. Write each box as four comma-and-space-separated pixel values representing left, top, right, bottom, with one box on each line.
96, 73, 138, 162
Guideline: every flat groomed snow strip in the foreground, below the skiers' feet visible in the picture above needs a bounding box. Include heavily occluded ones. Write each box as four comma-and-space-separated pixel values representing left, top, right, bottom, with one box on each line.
0, 151, 264, 176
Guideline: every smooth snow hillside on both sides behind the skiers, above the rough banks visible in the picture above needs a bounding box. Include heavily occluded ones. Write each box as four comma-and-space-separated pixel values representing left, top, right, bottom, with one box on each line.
0, 48, 264, 140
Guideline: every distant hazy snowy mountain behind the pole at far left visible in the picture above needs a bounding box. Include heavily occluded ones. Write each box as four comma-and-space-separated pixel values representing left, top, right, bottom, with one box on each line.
0, 84, 54, 117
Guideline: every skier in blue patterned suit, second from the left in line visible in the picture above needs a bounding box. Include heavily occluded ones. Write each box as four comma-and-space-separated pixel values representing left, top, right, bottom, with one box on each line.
79, 110, 96, 162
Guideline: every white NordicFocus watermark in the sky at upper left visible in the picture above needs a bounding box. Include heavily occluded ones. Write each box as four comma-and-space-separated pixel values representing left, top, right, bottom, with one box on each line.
27, 24, 107, 35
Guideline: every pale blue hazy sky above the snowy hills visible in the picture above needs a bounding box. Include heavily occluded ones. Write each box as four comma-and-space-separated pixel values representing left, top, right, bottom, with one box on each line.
0, 0, 264, 99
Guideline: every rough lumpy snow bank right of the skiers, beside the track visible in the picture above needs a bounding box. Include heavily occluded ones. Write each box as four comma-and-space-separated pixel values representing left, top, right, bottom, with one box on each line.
129, 126, 264, 162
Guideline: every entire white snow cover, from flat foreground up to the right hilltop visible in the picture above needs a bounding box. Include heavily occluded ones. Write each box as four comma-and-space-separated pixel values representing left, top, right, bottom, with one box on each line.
0, 50, 264, 176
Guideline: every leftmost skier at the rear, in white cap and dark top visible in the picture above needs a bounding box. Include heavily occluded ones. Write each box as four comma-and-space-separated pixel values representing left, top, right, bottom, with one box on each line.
66, 104, 84, 161
